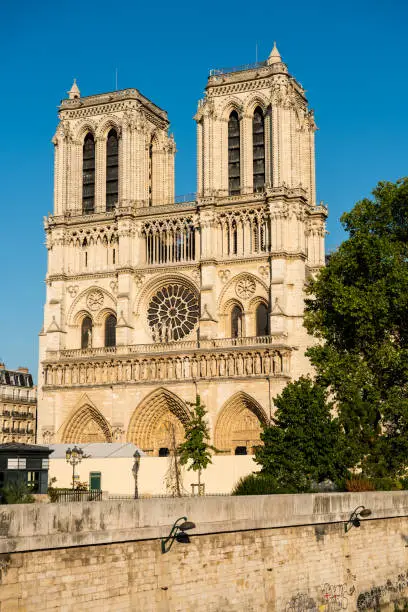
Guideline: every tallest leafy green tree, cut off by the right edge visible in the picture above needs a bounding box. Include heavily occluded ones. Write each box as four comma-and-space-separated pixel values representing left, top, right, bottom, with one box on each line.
305, 178, 408, 477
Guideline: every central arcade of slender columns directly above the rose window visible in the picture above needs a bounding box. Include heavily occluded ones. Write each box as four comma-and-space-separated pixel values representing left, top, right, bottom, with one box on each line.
143, 218, 195, 264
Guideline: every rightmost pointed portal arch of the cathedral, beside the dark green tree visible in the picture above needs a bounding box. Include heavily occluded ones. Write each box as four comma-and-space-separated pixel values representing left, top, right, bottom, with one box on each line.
214, 391, 268, 453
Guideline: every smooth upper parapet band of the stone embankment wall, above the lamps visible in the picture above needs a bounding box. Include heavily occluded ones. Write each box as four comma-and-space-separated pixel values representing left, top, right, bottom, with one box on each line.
0, 491, 408, 554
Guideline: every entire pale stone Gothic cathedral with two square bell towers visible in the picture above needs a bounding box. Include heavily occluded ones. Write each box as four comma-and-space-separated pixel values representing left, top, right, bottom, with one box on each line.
38, 45, 327, 456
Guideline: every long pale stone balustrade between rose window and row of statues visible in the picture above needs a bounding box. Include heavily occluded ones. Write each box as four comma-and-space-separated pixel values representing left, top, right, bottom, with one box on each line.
57, 334, 286, 358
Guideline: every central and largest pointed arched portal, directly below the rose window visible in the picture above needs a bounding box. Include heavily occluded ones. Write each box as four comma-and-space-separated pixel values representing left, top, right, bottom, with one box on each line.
127, 389, 189, 456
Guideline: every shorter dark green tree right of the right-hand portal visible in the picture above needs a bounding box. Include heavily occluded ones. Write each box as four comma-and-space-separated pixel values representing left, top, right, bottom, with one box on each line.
255, 377, 352, 492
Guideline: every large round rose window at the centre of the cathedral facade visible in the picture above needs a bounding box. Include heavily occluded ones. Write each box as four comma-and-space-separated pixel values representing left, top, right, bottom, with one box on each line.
147, 284, 199, 342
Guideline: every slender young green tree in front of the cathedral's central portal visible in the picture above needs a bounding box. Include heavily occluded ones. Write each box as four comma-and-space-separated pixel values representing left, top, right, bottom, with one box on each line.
178, 395, 217, 492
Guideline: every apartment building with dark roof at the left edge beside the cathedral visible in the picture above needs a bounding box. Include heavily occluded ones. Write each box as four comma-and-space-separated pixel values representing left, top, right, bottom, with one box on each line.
0, 363, 37, 444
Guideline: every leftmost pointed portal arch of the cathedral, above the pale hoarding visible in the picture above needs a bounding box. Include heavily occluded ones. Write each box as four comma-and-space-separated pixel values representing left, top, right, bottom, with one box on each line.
61, 404, 112, 444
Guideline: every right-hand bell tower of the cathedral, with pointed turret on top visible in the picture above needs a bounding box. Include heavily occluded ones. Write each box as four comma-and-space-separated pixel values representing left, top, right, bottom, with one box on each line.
196, 44, 316, 205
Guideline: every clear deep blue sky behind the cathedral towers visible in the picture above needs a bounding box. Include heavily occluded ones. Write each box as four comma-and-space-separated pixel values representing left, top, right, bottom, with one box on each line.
0, 0, 408, 378
